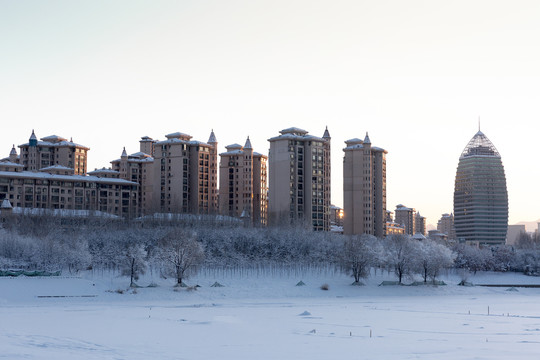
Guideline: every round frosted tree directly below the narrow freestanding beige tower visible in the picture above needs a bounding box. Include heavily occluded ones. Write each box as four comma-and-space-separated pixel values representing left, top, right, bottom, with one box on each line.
338, 234, 381, 284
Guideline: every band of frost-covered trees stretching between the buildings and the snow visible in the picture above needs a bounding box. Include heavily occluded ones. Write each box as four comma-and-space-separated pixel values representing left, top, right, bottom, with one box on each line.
0, 217, 540, 286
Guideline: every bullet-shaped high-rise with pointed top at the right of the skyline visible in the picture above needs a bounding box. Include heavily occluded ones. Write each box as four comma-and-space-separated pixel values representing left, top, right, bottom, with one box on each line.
454, 131, 508, 245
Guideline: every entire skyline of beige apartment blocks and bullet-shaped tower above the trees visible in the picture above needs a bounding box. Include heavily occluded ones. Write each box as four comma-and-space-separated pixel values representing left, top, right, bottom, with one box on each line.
0, 127, 508, 245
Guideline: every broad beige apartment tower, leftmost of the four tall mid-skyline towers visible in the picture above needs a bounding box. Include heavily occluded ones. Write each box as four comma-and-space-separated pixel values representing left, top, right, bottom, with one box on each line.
150, 131, 218, 214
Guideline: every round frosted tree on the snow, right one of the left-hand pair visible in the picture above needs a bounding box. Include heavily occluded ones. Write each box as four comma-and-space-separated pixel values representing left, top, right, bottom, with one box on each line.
156, 228, 204, 286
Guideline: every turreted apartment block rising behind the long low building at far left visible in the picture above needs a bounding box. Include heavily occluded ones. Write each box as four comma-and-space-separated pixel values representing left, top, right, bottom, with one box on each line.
19, 130, 90, 175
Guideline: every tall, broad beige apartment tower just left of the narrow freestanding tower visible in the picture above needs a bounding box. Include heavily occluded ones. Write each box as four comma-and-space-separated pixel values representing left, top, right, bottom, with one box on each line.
268, 127, 331, 231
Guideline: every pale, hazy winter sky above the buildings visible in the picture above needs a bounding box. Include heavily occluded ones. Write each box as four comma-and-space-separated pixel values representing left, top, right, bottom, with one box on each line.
0, 0, 540, 225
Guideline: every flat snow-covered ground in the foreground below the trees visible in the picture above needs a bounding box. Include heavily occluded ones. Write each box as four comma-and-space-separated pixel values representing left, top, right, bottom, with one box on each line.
0, 271, 540, 359
